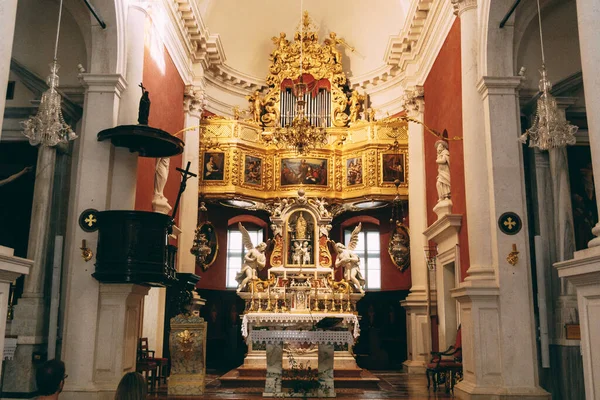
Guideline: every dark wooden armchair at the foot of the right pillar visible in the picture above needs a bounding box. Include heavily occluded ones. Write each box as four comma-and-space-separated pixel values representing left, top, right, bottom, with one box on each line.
425, 326, 462, 392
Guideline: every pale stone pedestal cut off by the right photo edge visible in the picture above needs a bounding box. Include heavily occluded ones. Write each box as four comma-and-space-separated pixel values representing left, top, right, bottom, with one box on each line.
554, 247, 600, 400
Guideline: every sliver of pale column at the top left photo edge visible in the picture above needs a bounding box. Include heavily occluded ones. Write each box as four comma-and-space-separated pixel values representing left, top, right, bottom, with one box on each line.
0, 0, 18, 139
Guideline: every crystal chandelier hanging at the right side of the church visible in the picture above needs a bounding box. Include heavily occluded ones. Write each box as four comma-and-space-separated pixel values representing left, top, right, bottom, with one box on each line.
519, 0, 579, 150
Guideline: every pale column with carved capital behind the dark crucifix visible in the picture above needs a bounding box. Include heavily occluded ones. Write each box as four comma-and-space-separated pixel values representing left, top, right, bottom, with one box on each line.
177, 85, 204, 274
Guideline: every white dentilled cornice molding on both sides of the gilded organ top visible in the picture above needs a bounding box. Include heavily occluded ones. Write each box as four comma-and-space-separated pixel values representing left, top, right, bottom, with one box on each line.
160, 0, 456, 115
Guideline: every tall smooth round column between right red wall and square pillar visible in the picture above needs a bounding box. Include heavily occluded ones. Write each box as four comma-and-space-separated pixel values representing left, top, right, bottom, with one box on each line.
452, 0, 495, 286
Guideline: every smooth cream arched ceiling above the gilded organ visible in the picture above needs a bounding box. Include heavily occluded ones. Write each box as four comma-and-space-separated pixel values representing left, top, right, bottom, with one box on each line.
197, 0, 411, 81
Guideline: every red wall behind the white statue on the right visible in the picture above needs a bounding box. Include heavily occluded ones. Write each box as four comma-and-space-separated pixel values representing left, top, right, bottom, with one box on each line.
424, 18, 469, 280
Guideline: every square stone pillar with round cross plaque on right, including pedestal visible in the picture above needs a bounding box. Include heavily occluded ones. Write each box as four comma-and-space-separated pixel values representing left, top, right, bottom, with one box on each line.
453, 77, 550, 399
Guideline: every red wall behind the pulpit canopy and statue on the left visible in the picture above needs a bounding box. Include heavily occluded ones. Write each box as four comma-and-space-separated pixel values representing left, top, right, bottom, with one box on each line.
135, 46, 184, 227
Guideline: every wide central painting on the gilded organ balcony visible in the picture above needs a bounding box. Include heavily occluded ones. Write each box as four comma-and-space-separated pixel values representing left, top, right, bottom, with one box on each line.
279, 158, 328, 186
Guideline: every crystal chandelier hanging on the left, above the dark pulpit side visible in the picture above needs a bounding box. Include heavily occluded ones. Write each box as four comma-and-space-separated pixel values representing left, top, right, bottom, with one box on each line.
22, 0, 77, 147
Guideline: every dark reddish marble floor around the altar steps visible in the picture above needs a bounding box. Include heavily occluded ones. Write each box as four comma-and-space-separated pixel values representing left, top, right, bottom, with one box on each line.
148, 371, 452, 400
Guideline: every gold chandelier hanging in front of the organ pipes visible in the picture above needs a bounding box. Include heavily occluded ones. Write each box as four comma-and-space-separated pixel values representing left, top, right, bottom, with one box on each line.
268, 1, 327, 154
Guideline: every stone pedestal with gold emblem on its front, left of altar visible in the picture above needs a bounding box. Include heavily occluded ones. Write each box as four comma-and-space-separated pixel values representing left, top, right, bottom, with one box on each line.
168, 314, 207, 396
